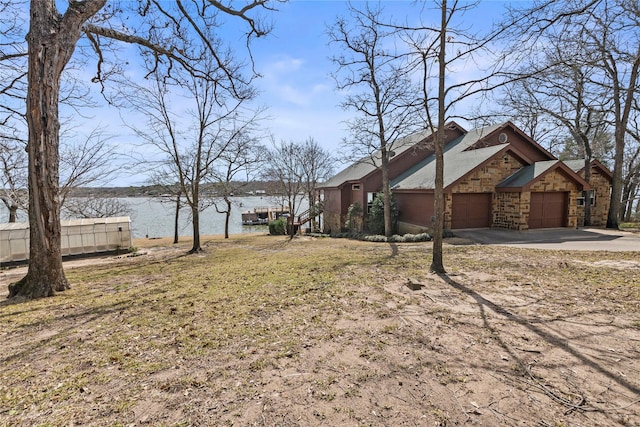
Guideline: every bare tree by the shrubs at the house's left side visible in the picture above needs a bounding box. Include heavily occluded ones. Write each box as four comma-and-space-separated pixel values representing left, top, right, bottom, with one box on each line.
329, 3, 418, 237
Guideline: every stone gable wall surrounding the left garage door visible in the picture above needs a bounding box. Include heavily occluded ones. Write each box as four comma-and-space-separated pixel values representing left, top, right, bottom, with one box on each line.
444, 153, 528, 230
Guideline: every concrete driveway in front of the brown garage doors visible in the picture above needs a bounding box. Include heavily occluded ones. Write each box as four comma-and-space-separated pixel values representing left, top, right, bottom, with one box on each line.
454, 228, 640, 252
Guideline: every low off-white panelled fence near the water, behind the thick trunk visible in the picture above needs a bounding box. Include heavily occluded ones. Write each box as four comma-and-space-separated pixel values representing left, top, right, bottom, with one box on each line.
0, 216, 133, 263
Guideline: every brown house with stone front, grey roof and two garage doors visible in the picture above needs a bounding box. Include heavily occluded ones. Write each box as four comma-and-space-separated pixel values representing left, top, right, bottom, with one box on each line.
321, 122, 610, 233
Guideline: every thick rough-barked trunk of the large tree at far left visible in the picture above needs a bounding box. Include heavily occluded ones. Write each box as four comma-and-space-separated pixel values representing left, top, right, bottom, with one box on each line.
9, 1, 79, 298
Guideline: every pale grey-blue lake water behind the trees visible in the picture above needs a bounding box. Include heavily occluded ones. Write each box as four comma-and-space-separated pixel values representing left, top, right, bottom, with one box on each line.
0, 196, 308, 238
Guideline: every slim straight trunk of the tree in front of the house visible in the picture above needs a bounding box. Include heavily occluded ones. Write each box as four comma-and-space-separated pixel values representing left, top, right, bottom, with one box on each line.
429, 0, 447, 274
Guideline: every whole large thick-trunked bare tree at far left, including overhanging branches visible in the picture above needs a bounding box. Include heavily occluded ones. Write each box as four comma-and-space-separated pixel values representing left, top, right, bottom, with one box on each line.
5, 0, 278, 298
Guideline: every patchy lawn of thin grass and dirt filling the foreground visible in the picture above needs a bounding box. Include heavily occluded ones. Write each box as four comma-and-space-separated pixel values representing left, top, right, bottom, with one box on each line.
0, 235, 640, 427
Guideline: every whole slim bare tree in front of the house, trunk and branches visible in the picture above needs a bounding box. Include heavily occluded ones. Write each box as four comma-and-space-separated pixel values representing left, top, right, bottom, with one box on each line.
401, 0, 508, 274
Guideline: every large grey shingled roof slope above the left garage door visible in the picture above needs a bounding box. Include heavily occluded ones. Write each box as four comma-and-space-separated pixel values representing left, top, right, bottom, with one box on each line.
391, 124, 509, 190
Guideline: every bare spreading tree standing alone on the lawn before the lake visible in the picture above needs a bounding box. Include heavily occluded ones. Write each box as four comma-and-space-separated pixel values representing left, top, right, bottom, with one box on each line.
128, 62, 252, 253
